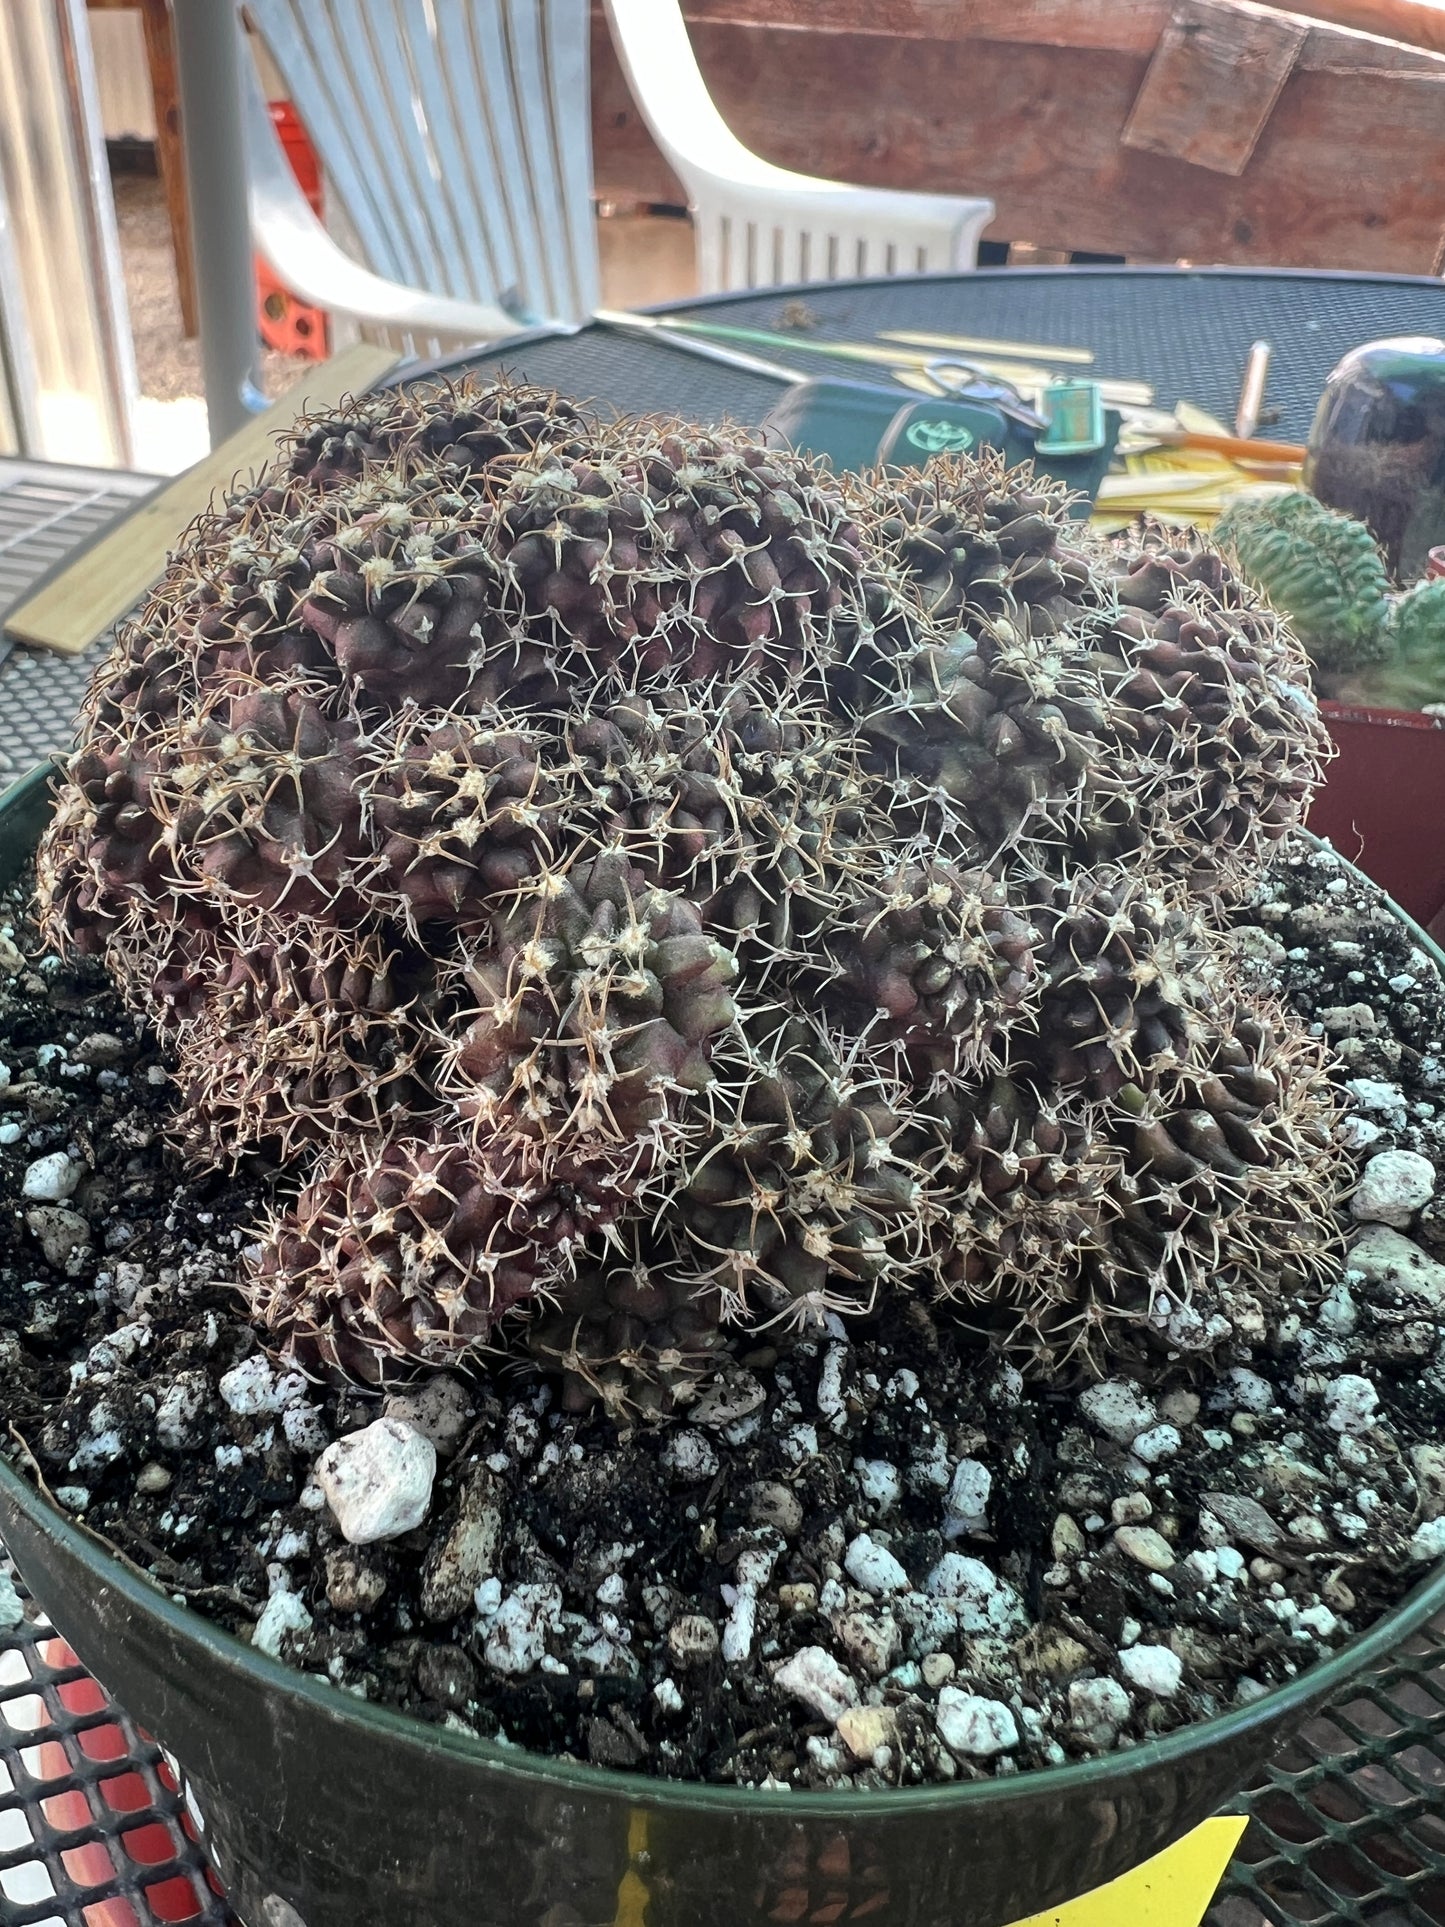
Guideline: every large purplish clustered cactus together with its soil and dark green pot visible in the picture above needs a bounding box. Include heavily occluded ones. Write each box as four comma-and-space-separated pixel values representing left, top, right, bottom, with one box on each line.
0, 383, 1445, 1927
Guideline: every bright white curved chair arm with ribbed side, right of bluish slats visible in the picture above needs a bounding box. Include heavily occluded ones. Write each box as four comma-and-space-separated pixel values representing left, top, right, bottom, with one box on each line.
605, 0, 994, 295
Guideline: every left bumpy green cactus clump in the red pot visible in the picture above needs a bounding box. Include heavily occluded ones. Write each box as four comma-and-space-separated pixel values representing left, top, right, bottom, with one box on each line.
1214, 491, 1395, 671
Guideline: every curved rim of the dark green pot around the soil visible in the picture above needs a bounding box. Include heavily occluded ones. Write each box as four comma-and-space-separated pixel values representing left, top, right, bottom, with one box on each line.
0, 765, 1445, 1821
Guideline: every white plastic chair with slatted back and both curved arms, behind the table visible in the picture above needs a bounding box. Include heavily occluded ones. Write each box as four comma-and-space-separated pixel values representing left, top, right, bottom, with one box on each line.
237, 0, 994, 353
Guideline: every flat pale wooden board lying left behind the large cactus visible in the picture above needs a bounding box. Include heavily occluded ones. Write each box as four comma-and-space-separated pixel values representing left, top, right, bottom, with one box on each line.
6, 341, 401, 655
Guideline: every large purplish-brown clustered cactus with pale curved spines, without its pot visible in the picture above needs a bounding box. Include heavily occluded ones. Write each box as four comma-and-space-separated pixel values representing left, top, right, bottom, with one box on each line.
39, 383, 1347, 1414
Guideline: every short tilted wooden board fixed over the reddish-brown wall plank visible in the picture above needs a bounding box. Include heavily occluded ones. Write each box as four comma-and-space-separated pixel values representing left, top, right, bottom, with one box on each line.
1119, 0, 1308, 173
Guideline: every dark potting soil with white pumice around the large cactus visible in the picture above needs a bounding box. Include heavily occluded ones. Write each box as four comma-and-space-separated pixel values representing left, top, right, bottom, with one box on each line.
0, 842, 1445, 1786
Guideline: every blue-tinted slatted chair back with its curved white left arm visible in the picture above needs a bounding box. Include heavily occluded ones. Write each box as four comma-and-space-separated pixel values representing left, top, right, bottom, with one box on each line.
245, 0, 597, 353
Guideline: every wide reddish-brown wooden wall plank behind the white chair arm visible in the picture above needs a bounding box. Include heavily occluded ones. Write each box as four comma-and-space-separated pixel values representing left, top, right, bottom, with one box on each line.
593, 0, 1445, 274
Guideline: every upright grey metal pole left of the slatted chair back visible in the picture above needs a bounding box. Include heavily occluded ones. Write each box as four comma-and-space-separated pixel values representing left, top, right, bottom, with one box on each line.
175, 0, 266, 447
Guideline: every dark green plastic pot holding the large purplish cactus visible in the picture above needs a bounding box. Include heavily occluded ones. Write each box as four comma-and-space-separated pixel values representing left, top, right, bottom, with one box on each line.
0, 771, 1445, 1927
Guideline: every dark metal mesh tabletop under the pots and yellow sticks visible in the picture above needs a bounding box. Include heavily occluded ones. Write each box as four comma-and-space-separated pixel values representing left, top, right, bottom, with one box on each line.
0, 268, 1445, 1927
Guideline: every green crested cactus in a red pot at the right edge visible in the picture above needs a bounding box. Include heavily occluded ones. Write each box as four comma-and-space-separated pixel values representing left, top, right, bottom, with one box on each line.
1216, 489, 1445, 929
